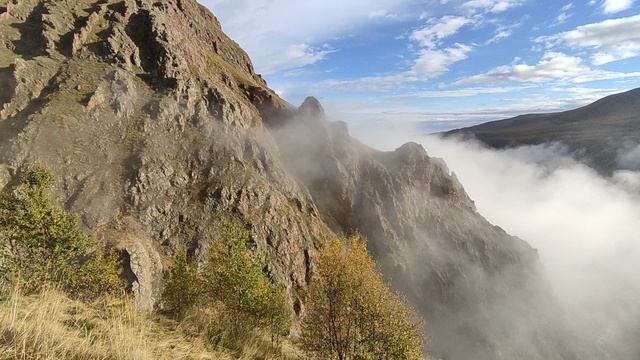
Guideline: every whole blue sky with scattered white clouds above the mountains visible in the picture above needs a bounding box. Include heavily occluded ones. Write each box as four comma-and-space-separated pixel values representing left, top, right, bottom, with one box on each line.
202, 0, 640, 131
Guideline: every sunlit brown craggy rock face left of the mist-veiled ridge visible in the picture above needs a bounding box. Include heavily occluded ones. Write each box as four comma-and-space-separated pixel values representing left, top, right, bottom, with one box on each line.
0, 0, 330, 308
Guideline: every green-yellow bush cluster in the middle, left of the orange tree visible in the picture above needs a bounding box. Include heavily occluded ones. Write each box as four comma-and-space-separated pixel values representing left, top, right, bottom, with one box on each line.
162, 222, 291, 342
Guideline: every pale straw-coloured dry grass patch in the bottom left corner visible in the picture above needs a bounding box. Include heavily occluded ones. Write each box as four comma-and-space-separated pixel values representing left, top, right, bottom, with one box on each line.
0, 290, 225, 360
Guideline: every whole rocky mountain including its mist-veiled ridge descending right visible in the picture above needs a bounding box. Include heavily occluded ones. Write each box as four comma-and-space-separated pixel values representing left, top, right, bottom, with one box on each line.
0, 0, 599, 360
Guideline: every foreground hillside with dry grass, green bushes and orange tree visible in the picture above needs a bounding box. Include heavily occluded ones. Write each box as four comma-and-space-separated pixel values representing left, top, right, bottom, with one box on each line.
0, 165, 423, 360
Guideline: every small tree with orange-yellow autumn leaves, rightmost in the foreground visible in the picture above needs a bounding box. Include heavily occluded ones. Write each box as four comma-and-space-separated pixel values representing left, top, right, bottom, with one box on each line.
302, 238, 424, 360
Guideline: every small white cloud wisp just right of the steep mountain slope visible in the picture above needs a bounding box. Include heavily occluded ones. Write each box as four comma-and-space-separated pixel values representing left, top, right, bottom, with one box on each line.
261, 44, 336, 75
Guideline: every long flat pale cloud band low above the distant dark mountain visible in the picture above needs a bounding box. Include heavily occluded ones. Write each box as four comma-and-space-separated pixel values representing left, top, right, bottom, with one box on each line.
324, 84, 633, 134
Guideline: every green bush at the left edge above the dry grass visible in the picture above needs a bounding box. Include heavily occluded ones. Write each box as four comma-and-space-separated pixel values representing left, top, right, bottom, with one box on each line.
0, 165, 124, 299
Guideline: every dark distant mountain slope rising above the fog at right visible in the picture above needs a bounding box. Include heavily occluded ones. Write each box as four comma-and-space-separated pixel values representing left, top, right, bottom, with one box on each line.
444, 89, 640, 173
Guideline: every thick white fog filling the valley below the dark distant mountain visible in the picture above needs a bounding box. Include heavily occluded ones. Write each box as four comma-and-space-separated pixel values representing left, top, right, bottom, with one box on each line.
353, 122, 640, 360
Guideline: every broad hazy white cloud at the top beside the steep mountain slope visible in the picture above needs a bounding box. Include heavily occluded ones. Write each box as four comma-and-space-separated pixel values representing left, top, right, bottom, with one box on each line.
205, 0, 411, 72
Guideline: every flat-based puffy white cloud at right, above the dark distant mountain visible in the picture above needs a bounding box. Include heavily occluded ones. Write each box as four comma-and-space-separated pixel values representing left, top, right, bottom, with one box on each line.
459, 52, 640, 83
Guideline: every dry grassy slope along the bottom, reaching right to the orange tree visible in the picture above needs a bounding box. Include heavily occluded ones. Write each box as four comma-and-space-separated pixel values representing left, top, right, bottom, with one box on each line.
0, 289, 299, 360
